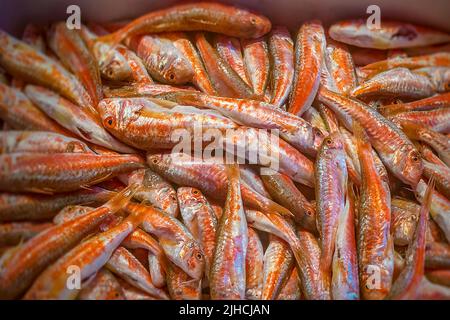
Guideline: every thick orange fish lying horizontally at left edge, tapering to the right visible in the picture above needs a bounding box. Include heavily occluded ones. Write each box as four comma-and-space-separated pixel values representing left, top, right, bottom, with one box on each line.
0, 153, 143, 193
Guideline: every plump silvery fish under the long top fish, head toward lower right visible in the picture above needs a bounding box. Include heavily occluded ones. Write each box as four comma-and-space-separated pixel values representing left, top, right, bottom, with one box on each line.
127, 35, 194, 84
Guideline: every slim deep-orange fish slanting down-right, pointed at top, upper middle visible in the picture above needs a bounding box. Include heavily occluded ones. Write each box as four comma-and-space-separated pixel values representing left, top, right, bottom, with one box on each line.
195, 33, 254, 98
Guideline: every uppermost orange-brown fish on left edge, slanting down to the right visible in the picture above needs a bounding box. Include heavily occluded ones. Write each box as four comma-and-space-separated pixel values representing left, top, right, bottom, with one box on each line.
0, 30, 95, 112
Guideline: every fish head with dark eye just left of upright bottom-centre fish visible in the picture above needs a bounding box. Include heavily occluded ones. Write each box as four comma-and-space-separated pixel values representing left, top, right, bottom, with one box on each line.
179, 240, 205, 280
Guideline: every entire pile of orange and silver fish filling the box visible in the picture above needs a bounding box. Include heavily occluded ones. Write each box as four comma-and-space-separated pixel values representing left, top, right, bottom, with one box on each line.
0, 2, 450, 300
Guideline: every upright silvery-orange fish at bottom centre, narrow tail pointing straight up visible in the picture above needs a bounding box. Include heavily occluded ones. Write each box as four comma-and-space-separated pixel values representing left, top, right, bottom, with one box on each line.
209, 164, 248, 300
